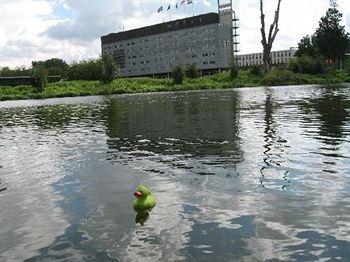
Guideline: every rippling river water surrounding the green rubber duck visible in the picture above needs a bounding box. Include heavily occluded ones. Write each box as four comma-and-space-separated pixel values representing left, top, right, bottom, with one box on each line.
0, 86, 350, 261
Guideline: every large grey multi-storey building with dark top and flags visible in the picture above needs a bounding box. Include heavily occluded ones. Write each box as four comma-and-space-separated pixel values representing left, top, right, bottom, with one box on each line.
101, 12, 233, 77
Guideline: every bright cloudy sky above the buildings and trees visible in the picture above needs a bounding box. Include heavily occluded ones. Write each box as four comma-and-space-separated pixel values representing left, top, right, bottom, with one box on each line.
0, 0, 350, 68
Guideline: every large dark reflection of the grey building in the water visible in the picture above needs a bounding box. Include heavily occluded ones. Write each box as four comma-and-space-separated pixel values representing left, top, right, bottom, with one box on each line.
106, 92, 242, 177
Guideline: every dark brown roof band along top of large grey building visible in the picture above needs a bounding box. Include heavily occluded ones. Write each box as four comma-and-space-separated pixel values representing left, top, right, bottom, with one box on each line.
101, 13, 220, 45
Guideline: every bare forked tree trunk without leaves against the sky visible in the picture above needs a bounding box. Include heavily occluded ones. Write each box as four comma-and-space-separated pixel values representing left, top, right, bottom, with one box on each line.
260, 0, 281, 71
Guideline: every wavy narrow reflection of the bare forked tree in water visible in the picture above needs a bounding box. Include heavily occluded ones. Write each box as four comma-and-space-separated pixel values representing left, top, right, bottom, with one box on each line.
260, 89, 290, 189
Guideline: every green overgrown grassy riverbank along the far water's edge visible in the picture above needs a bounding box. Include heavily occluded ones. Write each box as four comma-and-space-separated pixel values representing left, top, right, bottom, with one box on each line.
0, 70, 350, 101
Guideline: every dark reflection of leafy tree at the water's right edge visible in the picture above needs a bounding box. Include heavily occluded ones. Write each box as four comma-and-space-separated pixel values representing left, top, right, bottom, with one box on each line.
301, 87, 350, 173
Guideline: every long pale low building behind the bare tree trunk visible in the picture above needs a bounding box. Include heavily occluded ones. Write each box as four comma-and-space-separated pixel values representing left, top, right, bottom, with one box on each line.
237, 48, 297, 67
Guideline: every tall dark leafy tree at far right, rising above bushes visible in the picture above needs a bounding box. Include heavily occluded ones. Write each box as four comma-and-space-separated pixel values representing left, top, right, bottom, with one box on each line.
314, 6, 350, 67
